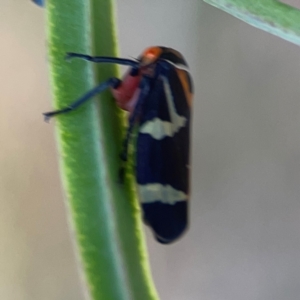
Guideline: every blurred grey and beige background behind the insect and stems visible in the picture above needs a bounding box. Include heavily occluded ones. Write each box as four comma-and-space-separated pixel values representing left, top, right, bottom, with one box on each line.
0, 0, 300, 300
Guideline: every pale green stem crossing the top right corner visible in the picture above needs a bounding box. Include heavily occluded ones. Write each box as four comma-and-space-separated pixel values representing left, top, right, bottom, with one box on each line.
204, 0, 300, 45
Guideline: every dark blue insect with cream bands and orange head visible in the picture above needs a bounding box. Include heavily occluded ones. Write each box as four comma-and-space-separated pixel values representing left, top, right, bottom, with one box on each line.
44, 46, 193, 244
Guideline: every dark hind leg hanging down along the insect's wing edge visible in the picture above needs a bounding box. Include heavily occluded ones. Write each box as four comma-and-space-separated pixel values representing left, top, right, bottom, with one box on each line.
119, 77, 150, 183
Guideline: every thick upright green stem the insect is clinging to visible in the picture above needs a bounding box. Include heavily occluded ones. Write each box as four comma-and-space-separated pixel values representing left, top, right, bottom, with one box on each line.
47, 0, 158, 300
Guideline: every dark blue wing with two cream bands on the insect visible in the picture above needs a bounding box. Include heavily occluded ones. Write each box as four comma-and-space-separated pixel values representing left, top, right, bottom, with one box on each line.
136, 64, 190, 243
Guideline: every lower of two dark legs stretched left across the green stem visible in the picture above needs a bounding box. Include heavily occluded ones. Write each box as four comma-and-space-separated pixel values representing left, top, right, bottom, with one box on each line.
43, 77, 121, 121
